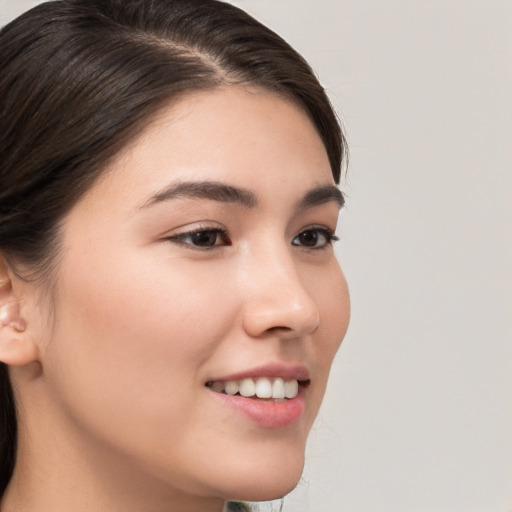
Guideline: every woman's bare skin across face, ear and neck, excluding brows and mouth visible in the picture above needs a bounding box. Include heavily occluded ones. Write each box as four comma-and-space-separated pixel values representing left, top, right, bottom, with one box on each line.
0, 87, 349, 512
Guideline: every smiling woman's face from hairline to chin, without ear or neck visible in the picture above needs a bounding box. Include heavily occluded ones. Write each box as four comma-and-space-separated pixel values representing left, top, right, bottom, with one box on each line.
36, 87, 349, 500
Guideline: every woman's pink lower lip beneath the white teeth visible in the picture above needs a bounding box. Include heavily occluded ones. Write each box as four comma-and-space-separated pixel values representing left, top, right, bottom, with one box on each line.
208, 387, 304, 429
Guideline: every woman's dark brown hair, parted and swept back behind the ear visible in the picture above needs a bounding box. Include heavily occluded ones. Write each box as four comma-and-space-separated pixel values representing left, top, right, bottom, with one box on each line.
0, 0, 346, 494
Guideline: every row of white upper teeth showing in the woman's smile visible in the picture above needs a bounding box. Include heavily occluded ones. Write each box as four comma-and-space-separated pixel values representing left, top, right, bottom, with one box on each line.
209, 377, 299, 399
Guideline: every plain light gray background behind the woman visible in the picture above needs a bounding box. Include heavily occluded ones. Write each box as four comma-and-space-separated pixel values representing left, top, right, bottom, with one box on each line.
0, 0, 512, 512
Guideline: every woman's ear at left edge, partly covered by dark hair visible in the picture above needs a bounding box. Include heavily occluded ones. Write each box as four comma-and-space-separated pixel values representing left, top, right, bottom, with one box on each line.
0, 255, 38, 366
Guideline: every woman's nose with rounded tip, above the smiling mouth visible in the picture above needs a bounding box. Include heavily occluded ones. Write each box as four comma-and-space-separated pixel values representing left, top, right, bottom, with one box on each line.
243, 251, 320, 339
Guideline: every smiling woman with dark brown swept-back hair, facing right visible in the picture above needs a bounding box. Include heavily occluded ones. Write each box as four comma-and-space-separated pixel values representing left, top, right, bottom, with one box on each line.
0, 0, 349, 512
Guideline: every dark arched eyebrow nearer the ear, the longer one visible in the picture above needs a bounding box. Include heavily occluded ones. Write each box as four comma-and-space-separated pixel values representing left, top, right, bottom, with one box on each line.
142, 181, 258, 208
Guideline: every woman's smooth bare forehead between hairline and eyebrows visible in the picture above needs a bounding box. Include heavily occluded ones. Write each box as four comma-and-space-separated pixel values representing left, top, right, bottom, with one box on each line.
89, 86, 334, 208
